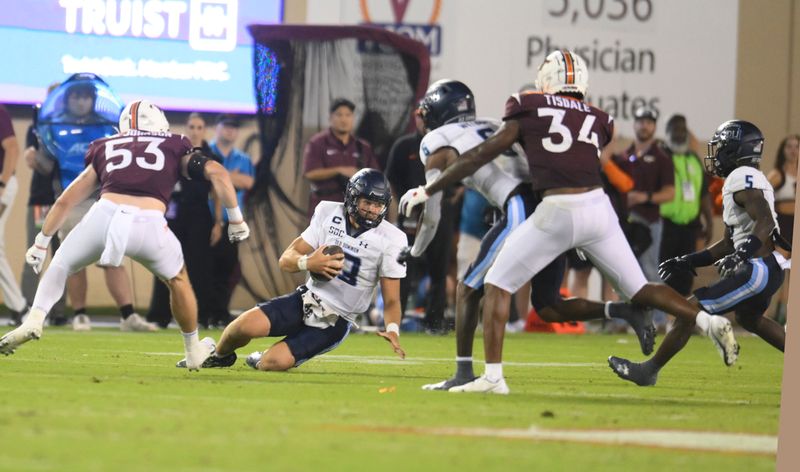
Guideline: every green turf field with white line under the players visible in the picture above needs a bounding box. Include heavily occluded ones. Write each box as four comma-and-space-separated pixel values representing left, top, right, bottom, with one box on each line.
0, 328, 783, 472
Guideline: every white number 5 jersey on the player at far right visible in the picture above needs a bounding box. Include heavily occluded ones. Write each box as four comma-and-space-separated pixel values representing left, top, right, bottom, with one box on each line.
722, 166, 778, 247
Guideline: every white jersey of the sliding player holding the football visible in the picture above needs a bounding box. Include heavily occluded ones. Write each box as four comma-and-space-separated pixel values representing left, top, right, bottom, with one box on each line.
300, 201, 408, 321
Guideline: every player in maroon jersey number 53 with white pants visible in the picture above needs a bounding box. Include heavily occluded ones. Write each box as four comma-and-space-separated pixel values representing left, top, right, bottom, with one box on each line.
0, 100, 250, 370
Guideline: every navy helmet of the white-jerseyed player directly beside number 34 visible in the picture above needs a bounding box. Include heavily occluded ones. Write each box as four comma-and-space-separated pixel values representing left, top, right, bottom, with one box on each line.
419, 79, 475, 130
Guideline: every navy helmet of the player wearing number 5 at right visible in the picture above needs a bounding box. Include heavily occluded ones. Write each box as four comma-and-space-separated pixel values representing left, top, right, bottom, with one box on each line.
705, 120, 764, 178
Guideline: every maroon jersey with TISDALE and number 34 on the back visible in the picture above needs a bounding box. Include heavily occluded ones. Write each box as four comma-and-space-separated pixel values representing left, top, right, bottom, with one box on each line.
503, 93, 614, 190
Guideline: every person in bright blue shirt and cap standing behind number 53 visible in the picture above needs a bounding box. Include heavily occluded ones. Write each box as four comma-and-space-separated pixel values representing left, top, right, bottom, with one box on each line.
208, 113, 256, 327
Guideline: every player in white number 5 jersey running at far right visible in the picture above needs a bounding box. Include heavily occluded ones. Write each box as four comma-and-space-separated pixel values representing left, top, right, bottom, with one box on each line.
608, 120, 790, 386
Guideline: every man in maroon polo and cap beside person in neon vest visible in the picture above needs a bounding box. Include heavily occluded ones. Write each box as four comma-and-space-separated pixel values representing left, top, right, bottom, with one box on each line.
613, 106, 675, 327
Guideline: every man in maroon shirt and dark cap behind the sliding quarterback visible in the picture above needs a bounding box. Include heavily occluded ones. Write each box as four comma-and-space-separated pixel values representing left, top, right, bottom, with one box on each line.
303, 98, 381, 217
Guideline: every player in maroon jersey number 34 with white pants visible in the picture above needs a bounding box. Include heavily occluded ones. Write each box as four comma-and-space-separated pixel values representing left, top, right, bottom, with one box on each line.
400, 50, 739, 394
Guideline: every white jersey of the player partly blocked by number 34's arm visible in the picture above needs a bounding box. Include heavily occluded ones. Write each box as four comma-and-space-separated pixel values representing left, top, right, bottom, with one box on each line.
419, 118, 530, 209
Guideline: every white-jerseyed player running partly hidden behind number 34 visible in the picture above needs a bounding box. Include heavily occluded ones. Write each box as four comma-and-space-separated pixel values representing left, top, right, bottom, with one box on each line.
410, 79, 655, 390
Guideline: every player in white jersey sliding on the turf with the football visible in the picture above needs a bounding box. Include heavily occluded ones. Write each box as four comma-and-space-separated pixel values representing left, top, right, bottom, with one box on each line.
178, 169, 408, 370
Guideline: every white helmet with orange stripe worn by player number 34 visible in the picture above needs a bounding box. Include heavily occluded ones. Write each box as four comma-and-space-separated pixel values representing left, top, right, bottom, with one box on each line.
536, 49, 589, 97
